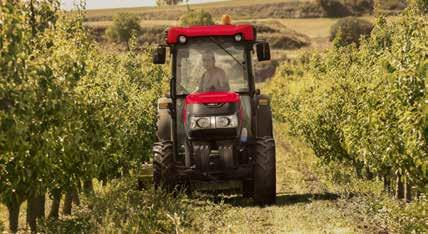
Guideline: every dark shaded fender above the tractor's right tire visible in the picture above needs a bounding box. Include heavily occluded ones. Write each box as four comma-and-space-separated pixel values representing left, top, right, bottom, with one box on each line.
255, 94, 273, 137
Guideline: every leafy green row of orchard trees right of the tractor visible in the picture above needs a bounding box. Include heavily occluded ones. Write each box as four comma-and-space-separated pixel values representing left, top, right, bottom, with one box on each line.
268, 1, 428, 195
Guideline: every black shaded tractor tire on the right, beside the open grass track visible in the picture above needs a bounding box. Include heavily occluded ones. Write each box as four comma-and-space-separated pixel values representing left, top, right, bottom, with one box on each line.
254, 137, 276, 206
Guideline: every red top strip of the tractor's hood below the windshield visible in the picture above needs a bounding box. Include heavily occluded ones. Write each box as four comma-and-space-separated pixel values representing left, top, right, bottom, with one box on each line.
186, 92, 240, 104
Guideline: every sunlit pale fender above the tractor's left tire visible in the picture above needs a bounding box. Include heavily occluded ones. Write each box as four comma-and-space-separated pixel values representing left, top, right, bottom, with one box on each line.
156, 97, 172, 141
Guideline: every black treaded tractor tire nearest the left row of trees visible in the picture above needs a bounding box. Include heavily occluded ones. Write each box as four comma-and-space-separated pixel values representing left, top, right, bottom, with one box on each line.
153, 141, 175, 190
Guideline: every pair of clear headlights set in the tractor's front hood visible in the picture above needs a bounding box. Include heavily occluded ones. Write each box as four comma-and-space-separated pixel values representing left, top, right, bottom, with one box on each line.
190, 114, 238, 129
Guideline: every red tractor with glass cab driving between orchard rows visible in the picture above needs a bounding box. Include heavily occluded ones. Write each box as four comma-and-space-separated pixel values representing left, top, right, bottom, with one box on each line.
153, 16, 276, 205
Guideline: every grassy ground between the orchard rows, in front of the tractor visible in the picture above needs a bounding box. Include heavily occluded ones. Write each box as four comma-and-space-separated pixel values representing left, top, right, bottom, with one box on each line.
0, 124, 428, 233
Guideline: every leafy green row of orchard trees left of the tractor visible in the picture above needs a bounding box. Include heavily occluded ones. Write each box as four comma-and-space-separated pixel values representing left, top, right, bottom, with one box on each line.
0, 0, 167, 229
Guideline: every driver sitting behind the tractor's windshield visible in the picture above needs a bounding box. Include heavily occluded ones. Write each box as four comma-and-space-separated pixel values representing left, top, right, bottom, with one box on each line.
198, 52, 230, 92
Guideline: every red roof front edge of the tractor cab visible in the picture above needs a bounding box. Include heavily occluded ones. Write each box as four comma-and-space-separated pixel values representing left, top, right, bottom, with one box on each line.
166, 24, 256, 44
